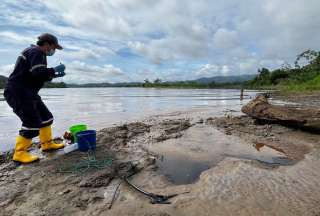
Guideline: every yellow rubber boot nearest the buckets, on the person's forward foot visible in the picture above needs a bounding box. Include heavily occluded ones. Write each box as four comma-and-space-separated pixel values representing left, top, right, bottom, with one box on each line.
39, 125, 64, 151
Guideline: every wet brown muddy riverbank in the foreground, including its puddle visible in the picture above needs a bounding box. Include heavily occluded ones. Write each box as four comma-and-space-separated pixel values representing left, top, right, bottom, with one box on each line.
0, 94, 320, 216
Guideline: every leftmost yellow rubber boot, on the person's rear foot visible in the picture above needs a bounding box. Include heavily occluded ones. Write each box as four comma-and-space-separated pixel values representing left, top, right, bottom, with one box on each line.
13, 135, 39, 163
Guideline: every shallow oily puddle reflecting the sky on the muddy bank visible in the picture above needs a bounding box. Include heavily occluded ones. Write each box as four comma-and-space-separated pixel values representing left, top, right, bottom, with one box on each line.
151, 125, 296, 185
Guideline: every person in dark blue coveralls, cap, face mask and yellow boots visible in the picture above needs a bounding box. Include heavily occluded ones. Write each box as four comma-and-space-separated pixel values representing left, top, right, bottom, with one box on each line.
4, 33, 65, 163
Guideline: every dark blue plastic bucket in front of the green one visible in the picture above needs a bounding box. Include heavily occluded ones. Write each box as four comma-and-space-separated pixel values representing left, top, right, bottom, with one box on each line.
76, 130, 97, 152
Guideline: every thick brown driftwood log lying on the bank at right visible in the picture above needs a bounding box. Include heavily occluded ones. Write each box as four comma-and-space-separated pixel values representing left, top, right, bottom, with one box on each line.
241, 95, 320, 133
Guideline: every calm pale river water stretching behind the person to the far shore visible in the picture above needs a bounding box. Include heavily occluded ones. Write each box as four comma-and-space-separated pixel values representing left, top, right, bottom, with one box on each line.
0, 88, 257, 151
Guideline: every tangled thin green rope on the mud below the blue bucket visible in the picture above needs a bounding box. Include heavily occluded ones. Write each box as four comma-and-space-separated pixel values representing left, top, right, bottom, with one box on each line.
58, 151, 113, 174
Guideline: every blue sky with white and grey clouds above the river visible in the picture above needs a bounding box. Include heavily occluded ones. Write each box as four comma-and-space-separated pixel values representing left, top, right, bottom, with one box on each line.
0, 0, 320, 83
